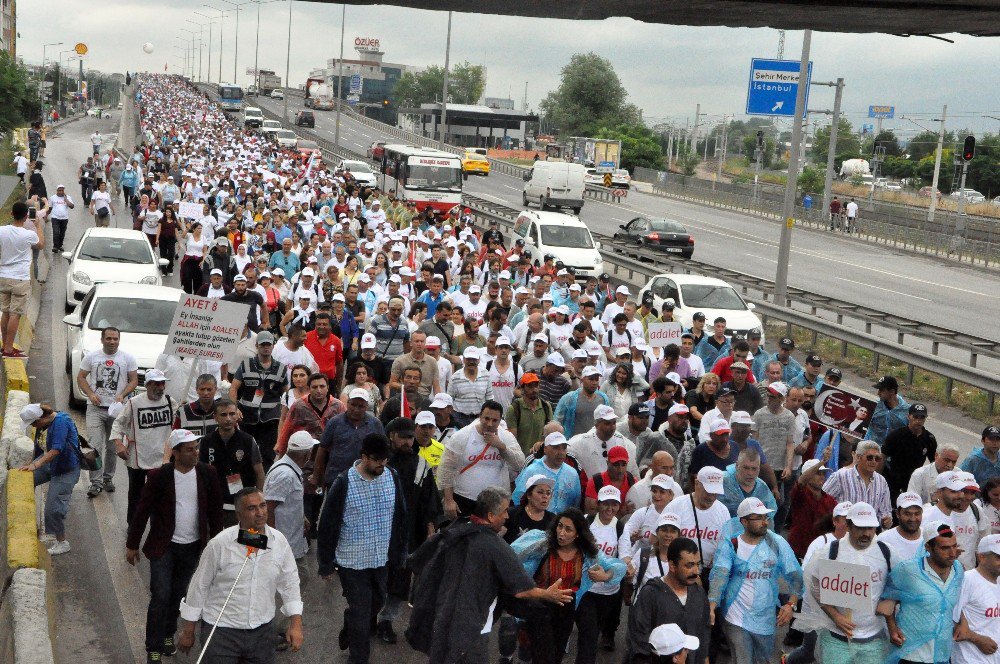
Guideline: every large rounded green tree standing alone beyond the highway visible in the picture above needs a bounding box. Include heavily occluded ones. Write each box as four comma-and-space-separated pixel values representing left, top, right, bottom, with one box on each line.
539, 53, 642, 136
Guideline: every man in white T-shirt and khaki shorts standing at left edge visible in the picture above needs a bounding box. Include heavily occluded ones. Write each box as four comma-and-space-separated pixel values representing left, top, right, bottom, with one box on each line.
0, 201, 45, 359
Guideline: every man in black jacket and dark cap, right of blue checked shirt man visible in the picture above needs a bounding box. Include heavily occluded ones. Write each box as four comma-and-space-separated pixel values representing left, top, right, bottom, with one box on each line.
377, 417, 443, 644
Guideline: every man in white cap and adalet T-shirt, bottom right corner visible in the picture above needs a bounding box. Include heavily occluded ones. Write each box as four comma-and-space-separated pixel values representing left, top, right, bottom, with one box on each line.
951, 535, 1000, 664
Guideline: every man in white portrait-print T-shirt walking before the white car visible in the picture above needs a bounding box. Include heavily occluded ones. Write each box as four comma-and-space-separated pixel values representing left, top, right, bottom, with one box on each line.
76, 327, 139, 498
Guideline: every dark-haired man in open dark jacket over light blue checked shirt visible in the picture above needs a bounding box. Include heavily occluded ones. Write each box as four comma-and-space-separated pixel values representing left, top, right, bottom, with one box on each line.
316, 433, 407, 664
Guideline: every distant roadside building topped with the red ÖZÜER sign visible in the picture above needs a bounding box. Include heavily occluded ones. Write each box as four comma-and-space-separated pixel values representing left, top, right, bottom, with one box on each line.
309, 37, 423, 125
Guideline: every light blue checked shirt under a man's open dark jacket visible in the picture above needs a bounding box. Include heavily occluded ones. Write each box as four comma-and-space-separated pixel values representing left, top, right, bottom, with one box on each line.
335, 463, 396, 569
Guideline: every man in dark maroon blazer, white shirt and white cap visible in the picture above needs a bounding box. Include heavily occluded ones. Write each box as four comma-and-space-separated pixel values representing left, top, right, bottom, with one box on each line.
125, 429, 222, 662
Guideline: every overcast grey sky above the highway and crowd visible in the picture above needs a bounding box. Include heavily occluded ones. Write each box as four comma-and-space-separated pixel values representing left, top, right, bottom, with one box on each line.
17, 0, 1000, 137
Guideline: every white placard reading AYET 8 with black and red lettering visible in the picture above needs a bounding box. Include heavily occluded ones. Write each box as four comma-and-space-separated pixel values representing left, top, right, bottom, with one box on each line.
163, 295, 250, 362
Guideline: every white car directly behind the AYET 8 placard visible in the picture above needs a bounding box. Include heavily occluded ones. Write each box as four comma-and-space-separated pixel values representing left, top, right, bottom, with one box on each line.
63, 283, 184, 407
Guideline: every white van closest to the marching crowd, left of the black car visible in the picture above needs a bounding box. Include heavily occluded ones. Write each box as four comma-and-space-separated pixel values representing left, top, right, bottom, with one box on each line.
514, 210, 604, 279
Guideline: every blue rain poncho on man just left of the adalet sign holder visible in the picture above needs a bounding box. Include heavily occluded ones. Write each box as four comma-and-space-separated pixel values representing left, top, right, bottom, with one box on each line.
708, 518, 802, 636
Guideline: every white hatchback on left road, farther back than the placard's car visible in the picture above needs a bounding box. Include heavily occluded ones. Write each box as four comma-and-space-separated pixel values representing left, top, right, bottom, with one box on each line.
62, 228, 167, 311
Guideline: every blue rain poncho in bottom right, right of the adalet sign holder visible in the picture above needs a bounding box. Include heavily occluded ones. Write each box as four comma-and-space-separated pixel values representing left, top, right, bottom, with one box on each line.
882, 555, 965, 664
